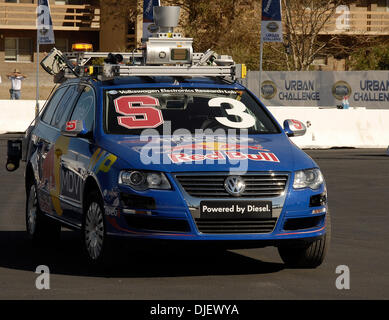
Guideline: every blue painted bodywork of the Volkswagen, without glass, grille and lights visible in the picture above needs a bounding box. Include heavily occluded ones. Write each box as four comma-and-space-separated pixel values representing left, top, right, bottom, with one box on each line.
30, 79, 327, 245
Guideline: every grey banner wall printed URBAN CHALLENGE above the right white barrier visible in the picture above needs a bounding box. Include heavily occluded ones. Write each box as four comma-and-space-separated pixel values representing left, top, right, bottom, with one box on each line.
246, 71, 389, 109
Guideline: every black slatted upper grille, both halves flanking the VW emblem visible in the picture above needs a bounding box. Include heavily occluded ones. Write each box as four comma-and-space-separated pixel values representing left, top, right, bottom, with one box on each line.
176, 173, 288, 198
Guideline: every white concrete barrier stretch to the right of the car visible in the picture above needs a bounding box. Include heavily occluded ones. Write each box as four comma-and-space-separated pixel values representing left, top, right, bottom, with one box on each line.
269, 107, 389, 148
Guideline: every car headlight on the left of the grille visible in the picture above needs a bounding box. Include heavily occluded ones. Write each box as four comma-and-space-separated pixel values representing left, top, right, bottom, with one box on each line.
119, 170, 171, 191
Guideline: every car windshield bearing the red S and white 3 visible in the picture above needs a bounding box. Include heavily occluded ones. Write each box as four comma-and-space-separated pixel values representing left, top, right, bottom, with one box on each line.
104, 88, 279, 135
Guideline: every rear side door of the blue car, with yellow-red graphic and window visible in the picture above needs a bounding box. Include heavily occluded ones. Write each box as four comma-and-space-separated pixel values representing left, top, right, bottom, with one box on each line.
35, 85, 77, 217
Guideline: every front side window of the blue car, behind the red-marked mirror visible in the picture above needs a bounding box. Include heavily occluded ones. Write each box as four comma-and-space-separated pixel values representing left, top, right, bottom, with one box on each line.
70, 87, 95, 131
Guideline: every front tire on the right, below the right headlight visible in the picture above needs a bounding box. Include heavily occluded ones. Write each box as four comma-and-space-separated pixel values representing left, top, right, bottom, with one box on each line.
278, 212, 331, 268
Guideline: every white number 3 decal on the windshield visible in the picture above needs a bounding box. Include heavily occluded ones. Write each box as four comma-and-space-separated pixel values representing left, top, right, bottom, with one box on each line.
208, 98, 255, 129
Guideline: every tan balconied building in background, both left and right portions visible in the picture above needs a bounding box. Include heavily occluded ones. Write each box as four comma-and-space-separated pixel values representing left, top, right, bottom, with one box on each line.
0, 0, 389, 99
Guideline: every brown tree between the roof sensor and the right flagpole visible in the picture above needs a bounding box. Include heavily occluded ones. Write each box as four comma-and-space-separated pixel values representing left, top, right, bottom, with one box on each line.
162, 0, 261, 69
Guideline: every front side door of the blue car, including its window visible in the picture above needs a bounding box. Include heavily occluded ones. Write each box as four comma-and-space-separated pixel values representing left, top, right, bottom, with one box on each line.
60, 85, 96, 226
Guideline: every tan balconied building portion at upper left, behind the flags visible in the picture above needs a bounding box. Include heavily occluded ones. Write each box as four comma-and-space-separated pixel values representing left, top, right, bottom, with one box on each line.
0, 0, 142, 99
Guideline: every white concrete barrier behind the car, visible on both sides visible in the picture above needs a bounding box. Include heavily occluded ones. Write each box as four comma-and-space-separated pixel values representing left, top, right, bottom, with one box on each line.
0, 100, 389, 148
